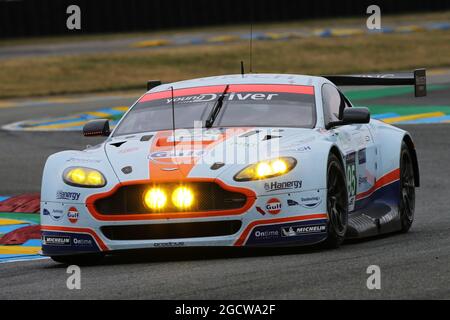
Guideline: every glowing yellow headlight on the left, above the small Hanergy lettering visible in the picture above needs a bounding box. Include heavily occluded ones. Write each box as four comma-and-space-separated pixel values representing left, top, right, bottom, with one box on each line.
63, 167, 106, 188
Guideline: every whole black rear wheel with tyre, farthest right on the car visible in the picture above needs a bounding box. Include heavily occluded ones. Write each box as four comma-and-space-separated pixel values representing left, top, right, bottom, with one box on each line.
399, 142, 416, 232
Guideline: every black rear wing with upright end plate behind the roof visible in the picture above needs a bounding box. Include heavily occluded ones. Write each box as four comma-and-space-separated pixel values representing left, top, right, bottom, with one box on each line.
322, 69, 427, 97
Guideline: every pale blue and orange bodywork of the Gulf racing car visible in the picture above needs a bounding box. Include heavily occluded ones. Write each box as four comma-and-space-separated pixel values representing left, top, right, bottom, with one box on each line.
41, 74, 418, 256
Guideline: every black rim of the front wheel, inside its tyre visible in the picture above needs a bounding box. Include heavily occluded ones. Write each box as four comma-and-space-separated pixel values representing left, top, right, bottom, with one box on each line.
327, 163, 348, 236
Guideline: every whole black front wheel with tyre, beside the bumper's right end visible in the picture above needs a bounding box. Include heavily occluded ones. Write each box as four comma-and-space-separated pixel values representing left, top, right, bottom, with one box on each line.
323, 154, 348, 248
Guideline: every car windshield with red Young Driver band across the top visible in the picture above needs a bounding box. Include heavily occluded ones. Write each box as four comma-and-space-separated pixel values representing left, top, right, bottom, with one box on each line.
114, 85, 316, 136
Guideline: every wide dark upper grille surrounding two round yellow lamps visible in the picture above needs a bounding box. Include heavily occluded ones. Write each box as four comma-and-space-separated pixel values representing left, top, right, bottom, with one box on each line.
94, 182, 247, 215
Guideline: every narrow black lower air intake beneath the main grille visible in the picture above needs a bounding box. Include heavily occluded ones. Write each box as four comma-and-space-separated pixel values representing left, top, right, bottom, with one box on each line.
100, 220, 242, 240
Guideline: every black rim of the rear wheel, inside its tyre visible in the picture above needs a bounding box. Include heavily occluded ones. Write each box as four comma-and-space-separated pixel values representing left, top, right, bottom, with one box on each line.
400, 152, 415, 222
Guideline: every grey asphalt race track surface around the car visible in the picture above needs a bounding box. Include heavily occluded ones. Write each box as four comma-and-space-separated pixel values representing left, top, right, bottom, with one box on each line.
0, 84, 450, 299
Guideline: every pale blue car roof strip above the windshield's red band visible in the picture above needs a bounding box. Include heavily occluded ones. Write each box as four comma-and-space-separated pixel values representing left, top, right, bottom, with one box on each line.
149, 73, 326, 93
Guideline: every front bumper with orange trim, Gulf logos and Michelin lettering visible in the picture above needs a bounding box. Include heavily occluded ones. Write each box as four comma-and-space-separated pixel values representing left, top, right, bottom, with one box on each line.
41, 189, 328, 256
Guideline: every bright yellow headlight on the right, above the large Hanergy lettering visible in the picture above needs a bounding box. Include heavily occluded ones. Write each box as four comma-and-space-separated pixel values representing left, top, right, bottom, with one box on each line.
234, 157, 297, 181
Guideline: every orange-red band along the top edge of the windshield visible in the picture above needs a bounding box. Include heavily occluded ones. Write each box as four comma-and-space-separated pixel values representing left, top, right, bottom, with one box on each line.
139, 84, 314, 102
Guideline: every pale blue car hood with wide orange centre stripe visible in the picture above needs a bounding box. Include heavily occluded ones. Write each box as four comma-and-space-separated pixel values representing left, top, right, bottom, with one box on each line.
104, 128, 320, 182
